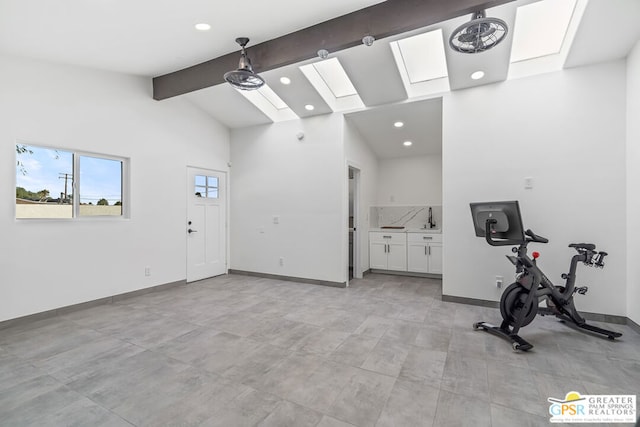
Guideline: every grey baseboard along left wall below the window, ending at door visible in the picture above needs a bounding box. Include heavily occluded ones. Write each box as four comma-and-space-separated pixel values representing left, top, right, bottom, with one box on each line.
0, 280, 187, 330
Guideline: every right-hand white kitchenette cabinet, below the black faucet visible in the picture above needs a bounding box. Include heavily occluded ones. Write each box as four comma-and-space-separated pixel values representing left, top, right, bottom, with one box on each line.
407, 233, 442, 274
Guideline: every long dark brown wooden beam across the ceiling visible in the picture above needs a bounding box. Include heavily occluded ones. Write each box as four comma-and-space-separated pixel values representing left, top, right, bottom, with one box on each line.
153, 0, 514, 100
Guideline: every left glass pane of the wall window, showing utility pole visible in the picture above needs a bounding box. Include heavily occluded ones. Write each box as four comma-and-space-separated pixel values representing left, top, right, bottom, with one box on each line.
16, 144, 73, 218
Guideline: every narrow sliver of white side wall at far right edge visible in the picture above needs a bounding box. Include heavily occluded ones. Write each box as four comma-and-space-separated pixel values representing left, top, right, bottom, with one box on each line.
627, 41, 640, 324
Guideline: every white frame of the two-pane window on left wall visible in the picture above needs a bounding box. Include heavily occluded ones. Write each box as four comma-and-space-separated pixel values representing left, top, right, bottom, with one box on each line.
13, 140, 131, 222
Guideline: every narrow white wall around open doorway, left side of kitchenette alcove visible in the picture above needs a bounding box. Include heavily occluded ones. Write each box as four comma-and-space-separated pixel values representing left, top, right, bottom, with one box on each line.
344, 120, 378, 271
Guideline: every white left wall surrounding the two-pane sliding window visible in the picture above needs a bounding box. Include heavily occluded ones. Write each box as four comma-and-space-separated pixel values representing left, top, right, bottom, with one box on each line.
0, 56, 229, 321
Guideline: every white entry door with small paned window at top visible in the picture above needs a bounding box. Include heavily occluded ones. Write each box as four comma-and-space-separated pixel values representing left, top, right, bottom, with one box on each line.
186, 167, 227, 282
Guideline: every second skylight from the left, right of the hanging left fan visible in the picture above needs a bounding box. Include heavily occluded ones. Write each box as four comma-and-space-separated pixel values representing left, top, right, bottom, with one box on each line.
300, 58, 364, 111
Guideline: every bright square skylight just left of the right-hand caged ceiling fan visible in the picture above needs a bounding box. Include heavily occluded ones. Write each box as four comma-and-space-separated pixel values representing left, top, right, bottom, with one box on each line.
396, 29, 447, 84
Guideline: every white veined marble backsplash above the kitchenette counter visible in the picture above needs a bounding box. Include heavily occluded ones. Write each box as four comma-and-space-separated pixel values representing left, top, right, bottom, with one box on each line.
369, 206, 442, 228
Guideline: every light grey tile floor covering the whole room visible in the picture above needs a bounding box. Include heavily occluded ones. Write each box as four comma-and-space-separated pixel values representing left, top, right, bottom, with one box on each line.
0, 274, 640, 427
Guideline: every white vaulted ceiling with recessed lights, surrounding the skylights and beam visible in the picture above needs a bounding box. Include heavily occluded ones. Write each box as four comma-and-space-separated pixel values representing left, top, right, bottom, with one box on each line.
0, 0, 640, 157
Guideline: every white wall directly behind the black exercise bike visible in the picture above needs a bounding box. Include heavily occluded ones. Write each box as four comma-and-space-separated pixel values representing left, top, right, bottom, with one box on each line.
443, 61, 637, 318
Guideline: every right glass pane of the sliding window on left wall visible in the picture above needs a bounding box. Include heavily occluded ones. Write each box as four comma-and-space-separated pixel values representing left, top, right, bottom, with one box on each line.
78, 156, 122, 216
